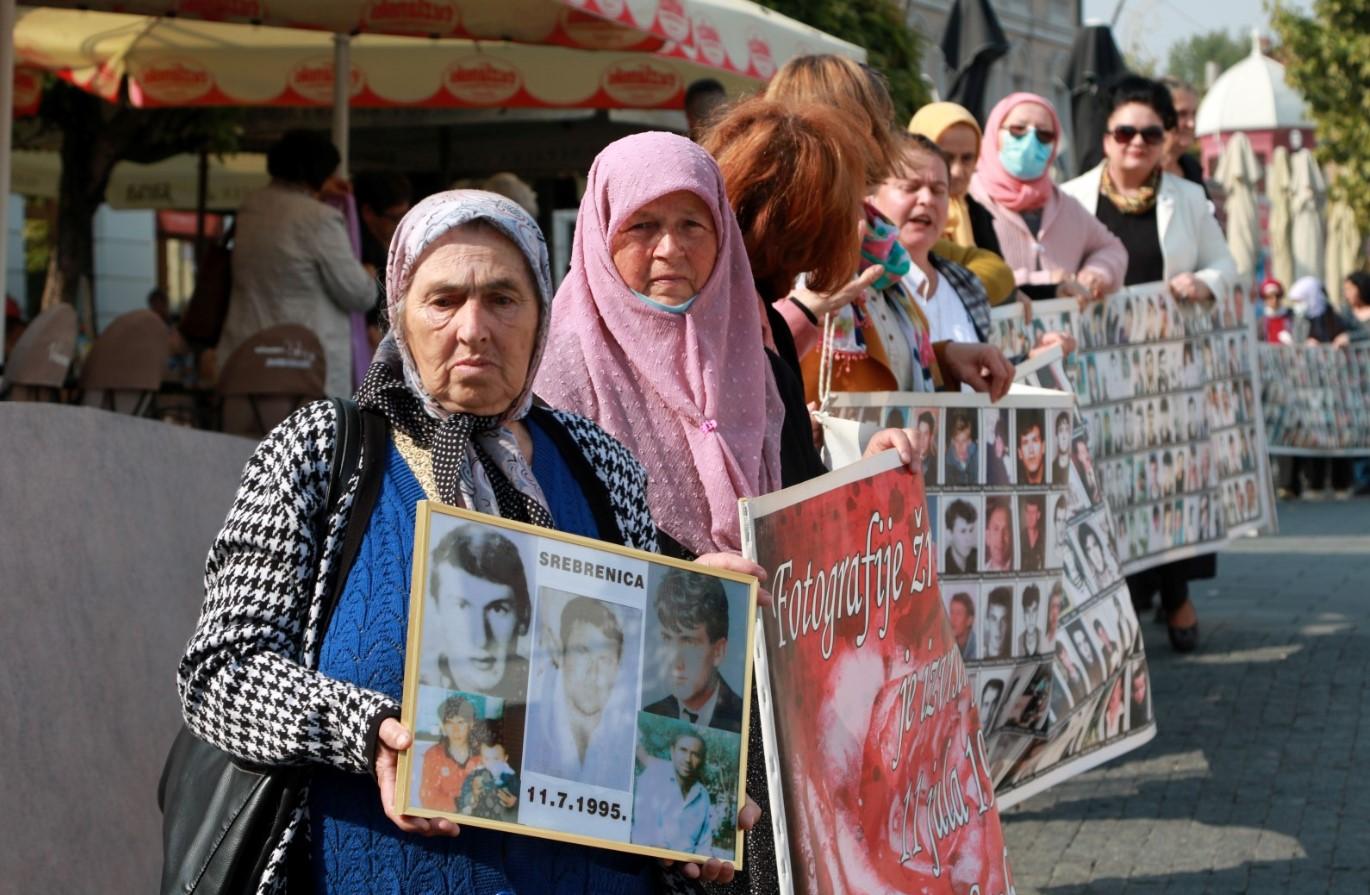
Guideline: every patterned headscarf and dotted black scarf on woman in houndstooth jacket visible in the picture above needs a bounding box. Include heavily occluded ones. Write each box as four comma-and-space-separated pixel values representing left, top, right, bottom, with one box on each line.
356, 189, 552, 528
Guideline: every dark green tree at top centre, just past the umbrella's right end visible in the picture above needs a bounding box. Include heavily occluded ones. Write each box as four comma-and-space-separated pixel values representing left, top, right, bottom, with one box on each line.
760, 0, 929, 121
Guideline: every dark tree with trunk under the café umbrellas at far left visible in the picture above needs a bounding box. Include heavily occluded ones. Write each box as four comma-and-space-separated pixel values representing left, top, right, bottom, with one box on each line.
26, 78, 238, 328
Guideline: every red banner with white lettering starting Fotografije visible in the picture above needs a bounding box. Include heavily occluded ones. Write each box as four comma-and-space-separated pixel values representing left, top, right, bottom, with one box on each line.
740, 451, 1014, 895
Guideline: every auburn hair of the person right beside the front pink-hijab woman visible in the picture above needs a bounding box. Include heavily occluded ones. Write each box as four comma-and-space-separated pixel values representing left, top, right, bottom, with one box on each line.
700, 97, 867, 300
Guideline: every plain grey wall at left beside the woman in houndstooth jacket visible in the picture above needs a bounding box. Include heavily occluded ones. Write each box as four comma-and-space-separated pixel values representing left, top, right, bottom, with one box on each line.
0, 402, 253, 892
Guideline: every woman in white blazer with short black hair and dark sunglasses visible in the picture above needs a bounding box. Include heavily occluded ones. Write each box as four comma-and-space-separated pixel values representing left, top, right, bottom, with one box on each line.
1060, 77, 1237, 652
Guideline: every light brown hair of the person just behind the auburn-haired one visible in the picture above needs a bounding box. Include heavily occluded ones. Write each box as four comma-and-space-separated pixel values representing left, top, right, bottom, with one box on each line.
766, 55, 900, 186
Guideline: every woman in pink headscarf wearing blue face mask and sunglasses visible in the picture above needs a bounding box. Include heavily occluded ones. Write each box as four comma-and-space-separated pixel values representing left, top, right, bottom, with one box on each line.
970, 93, 1128, 302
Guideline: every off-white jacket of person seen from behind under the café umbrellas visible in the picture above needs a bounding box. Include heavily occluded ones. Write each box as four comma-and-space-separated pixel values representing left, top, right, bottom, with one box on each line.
216, 182, 377, 397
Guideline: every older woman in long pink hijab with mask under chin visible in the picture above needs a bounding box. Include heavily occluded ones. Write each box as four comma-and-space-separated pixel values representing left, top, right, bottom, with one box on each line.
534, 133, 914, 558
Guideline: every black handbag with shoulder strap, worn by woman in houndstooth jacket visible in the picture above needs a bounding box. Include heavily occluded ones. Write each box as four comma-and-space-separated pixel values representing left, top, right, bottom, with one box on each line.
158, 397, 386, 895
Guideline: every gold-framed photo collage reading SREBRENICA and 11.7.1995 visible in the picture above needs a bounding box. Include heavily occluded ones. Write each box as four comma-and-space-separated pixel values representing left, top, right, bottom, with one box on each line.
395, 500, 758, 868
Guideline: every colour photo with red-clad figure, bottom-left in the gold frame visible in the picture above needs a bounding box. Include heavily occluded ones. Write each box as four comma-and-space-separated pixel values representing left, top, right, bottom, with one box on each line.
410, 684, 525, 824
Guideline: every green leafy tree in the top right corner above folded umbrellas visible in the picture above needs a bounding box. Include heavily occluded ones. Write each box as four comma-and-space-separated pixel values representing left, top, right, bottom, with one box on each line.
1274, 0, 1370, 230
